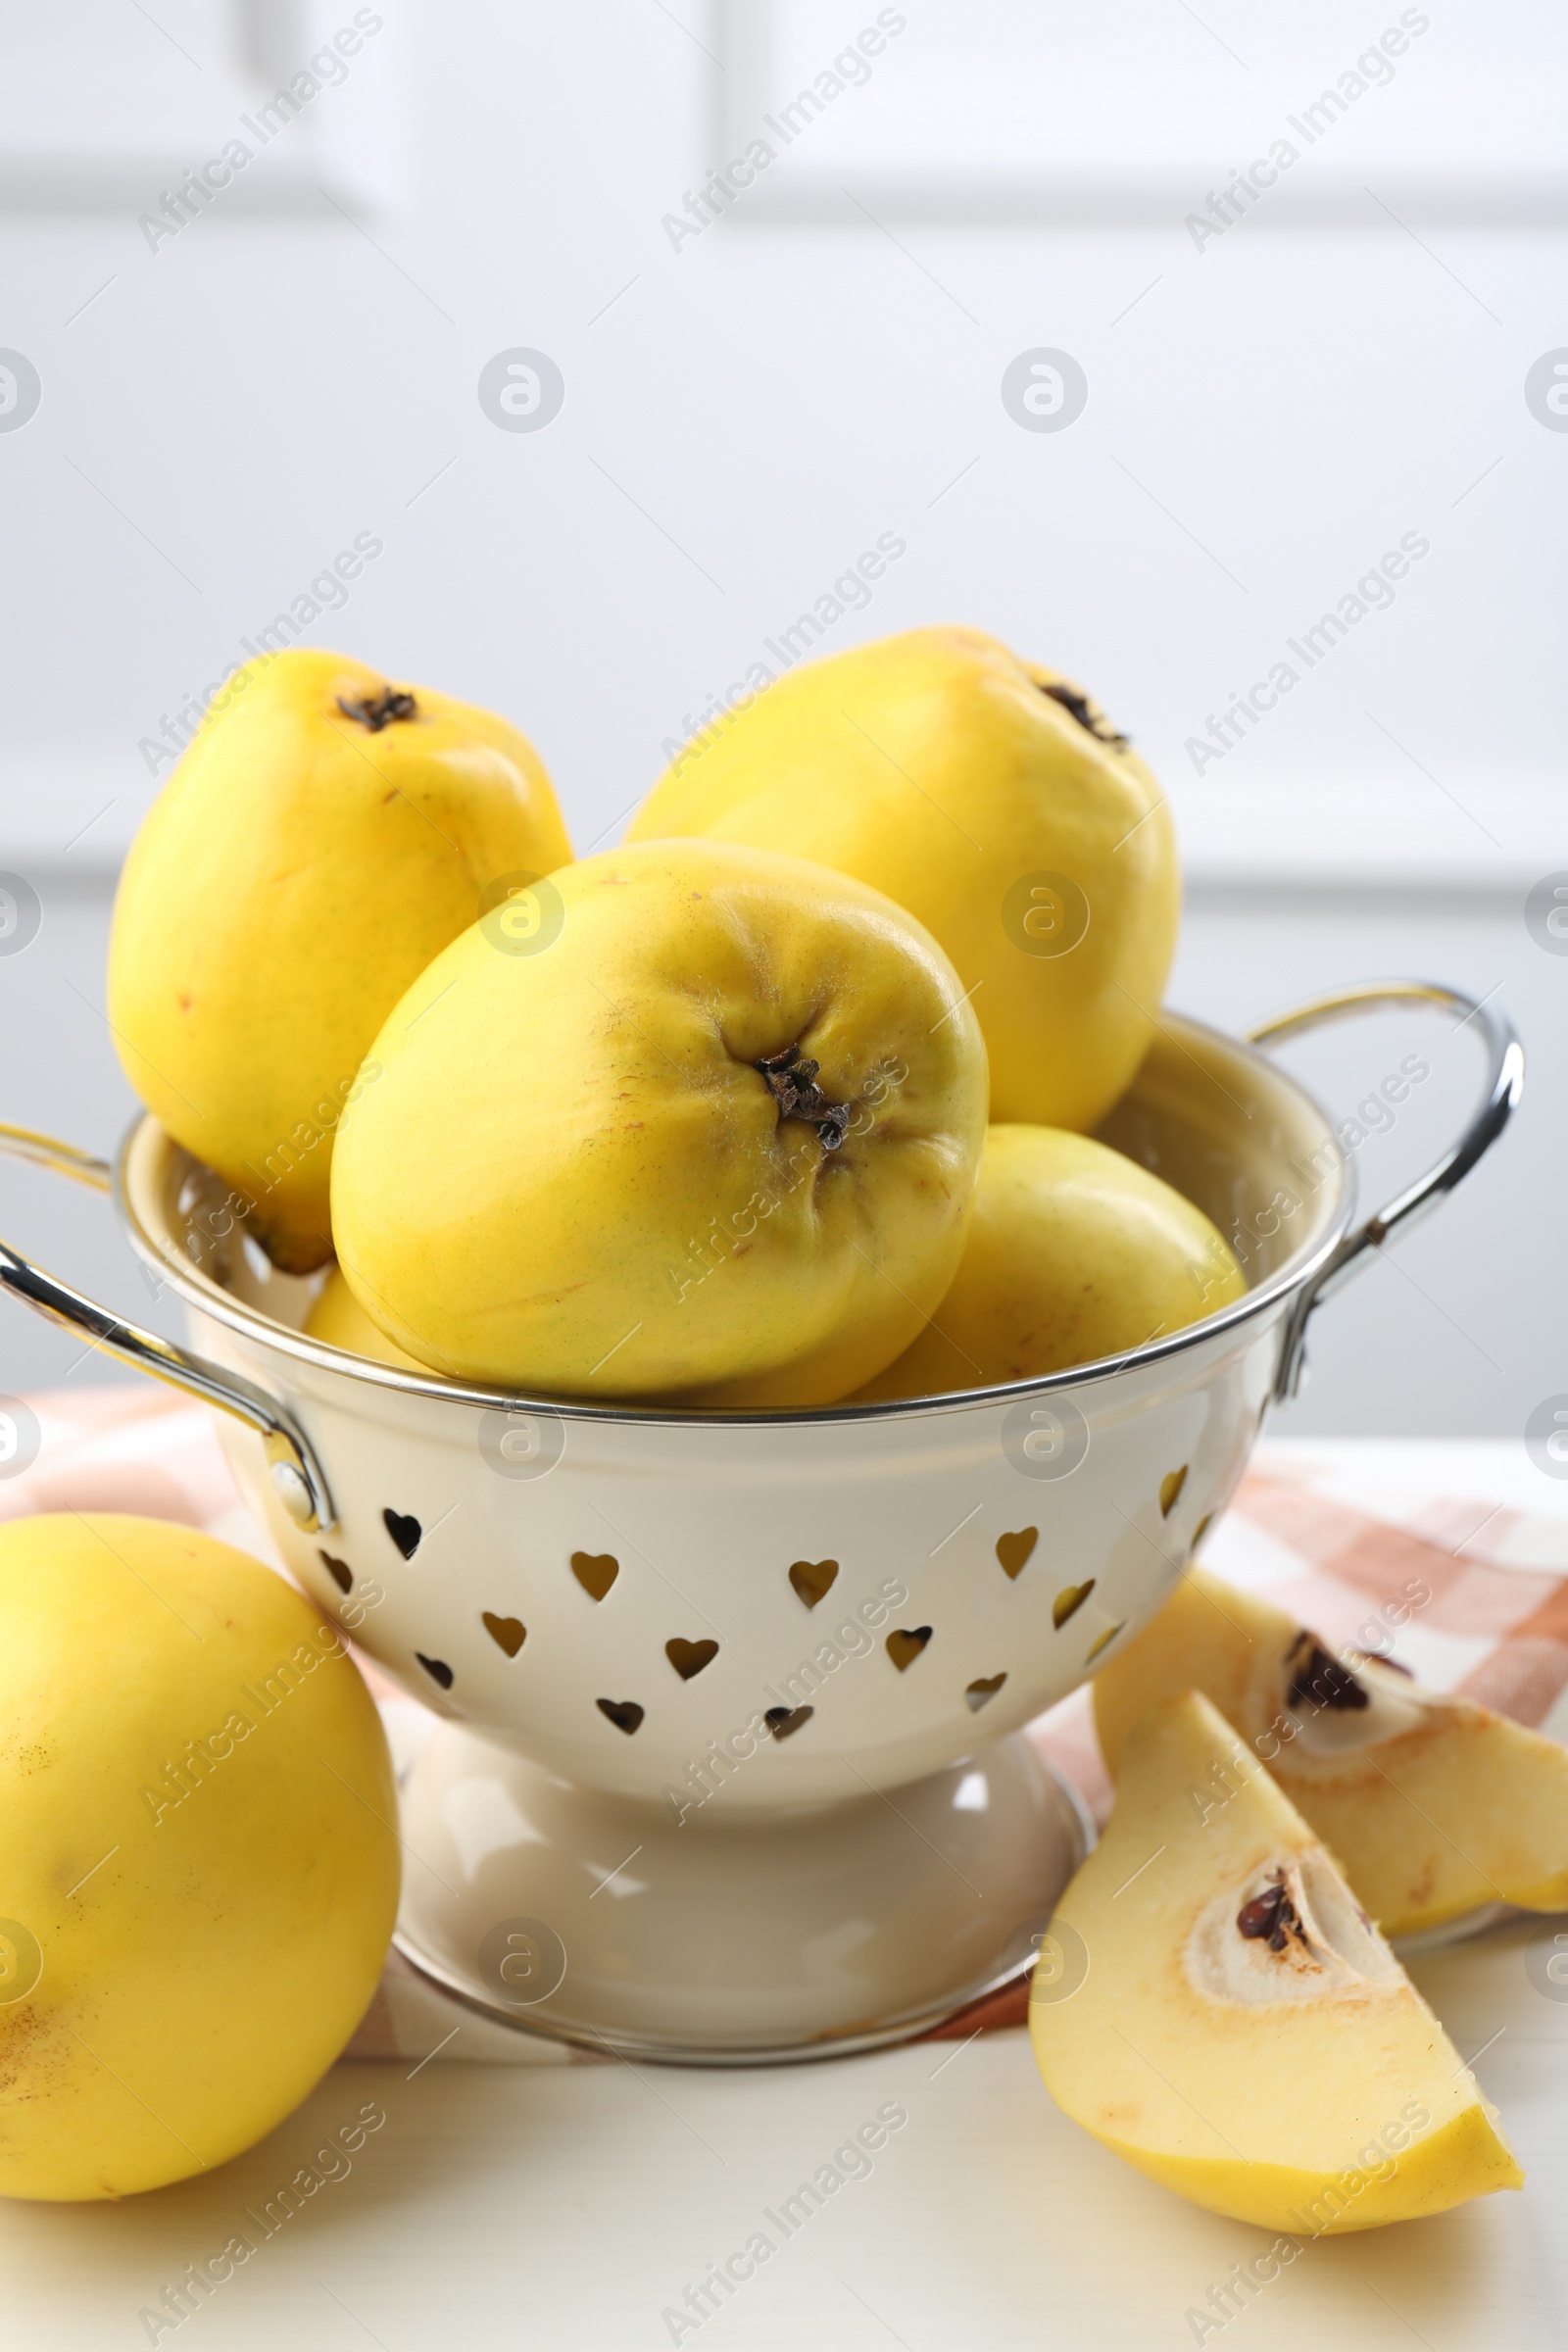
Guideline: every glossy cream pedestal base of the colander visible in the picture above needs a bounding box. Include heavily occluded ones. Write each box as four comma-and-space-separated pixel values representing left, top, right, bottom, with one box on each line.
397, 1724, 1093, 2065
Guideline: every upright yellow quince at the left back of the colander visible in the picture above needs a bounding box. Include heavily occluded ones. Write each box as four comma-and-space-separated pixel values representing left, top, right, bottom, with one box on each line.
108, 647, 571, 1272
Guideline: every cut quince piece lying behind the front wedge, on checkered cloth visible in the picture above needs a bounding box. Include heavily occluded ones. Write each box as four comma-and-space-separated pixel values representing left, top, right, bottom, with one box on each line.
1093, 1569, 1568, 1936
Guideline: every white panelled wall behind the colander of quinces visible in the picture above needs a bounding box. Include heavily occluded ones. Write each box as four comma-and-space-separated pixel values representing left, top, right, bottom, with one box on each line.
0, 0, 1568, 1433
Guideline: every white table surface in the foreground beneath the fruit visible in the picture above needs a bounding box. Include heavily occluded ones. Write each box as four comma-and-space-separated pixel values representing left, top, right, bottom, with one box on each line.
12, 1448, 1568, 2352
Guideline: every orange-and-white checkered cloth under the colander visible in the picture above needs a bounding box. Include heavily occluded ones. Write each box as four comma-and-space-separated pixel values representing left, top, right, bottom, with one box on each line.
12, 1386, 1568, 2065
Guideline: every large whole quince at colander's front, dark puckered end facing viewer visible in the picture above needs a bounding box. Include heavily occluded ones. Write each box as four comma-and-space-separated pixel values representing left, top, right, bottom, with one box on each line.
331, 842, 985, 1406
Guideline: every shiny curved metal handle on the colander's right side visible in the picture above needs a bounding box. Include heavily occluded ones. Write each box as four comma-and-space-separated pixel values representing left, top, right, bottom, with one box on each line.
1249, 981, 1523, 1404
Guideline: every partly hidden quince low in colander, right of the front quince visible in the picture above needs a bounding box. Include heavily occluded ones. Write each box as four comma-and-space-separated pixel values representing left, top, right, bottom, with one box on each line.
858, 1127, 1246, 1401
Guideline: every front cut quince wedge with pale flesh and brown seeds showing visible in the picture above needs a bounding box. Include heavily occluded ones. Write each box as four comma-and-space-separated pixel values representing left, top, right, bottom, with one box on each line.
1030, 1691, 1523, 2236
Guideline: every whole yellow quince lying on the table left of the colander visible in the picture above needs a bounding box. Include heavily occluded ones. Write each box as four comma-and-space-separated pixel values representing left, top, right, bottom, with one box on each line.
0, 1512, 400, 2199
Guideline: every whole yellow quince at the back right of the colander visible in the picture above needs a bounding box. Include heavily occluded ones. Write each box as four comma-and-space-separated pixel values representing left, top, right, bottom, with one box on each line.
627, 628, 1180, 1129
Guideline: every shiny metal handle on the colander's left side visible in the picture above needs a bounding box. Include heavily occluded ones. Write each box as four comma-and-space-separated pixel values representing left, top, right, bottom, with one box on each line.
0, 1119, 334, 1534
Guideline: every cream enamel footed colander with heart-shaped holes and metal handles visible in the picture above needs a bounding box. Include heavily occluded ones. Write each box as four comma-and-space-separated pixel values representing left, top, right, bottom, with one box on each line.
0, 981, 1523, 2063
